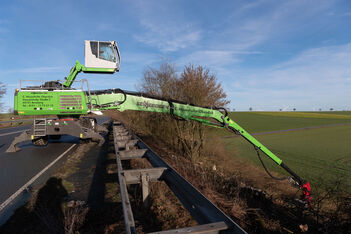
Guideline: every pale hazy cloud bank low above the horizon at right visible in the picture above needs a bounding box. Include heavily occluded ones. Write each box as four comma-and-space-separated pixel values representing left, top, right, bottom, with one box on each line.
228, 43, 351, 109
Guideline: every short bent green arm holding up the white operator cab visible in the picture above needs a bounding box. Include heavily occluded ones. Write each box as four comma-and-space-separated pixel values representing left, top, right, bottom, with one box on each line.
63, 60, 115, 88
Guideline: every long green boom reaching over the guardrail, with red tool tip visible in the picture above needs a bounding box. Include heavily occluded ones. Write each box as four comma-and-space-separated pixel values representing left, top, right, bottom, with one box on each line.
87, 89, 311, 203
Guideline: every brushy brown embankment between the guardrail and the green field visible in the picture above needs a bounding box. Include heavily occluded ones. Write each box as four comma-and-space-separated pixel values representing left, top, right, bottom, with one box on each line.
106, 112, 351, 233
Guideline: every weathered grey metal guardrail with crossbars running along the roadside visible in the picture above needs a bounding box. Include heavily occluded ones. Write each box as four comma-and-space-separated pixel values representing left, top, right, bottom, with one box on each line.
113, 122, 246, 233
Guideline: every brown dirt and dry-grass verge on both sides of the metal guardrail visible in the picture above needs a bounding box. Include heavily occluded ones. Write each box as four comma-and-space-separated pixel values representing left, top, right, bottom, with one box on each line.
0, 115, 347, 233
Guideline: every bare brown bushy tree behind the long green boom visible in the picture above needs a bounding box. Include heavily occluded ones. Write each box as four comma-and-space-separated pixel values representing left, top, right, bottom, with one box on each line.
141, 63, 229, 160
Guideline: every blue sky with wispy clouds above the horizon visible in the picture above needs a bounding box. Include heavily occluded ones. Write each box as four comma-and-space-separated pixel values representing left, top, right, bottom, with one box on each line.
0, 0, 351, 110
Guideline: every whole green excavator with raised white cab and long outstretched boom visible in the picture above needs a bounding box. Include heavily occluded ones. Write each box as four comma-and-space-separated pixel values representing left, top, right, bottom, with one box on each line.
6, 41, 311, 205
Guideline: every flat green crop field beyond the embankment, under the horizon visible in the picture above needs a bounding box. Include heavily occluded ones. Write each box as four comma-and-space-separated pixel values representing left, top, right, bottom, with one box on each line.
216, 112, 351, 191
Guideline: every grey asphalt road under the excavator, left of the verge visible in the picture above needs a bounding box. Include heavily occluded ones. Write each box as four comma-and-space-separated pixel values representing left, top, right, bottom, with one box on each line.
0, 116, 108, 224
